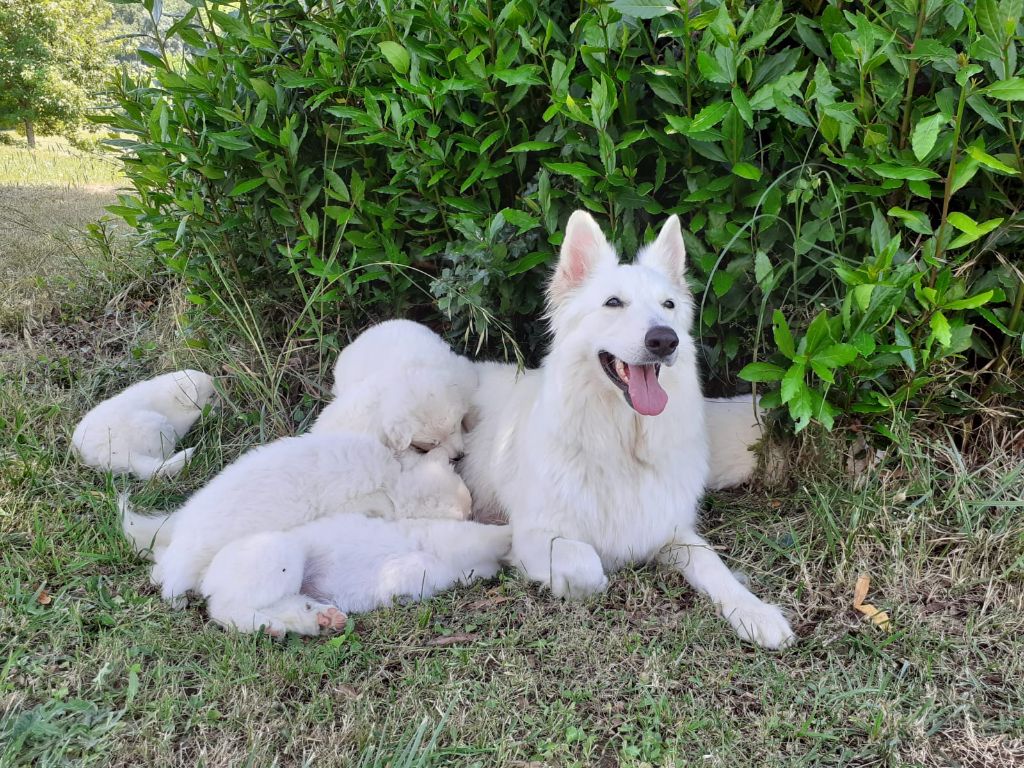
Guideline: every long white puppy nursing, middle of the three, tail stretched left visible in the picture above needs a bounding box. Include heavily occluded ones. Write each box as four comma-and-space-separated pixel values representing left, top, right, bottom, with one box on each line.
121, 432, 470, 605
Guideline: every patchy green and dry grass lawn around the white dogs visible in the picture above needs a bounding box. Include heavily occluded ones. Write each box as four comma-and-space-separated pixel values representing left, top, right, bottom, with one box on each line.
0, 135, 1024, 768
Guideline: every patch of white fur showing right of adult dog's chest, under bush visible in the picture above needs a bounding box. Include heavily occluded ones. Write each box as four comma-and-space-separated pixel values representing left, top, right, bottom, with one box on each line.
705, 394, 764, 490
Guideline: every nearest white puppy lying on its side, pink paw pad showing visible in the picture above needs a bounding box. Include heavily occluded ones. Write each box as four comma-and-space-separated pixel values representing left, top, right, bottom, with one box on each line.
201, 514, 511, 635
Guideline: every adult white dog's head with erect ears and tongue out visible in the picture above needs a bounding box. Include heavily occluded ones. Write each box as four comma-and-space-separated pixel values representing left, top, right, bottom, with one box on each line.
548, 211, 693, 416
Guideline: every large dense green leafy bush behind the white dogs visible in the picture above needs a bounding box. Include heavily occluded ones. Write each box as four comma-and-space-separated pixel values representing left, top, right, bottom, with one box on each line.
108, 0, 1024, 432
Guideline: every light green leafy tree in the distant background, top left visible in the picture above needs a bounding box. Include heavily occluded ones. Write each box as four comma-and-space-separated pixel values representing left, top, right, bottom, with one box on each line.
0, 0, 117, 148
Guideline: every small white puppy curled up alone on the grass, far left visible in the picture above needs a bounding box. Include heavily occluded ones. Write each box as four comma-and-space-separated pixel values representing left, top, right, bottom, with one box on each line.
72, 370, 215, 479
